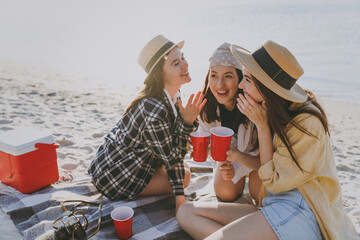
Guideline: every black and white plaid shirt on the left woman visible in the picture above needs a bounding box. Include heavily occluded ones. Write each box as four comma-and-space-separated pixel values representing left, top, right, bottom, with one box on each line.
88, 92, 197, 200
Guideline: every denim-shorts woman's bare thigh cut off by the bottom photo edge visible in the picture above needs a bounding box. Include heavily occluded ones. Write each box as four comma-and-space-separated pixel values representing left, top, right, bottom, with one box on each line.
206, 211, 278, 240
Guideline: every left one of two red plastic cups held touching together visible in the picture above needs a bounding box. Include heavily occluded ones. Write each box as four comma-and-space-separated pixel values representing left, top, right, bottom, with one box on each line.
190, 131, 210, 162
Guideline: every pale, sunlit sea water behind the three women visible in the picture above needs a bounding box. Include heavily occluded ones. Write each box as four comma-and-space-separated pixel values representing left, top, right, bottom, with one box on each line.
0, 0, 360, 103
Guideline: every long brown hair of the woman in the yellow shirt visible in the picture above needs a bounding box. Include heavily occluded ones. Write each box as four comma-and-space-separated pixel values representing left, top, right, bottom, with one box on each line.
251, 75, 330, 171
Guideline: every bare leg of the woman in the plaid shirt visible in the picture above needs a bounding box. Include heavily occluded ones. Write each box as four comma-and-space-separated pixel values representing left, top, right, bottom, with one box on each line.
139, 163, 191, 196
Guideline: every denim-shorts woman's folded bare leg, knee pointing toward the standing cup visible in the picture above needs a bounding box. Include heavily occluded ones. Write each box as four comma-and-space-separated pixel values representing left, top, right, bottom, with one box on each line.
176, 202, 257, 239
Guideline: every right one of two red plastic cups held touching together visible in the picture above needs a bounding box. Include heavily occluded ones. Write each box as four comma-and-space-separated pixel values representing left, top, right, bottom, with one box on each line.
210, 127, 234, 162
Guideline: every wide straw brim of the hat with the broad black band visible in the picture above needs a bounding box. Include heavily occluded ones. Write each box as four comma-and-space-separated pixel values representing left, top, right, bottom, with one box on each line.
230, 45, 308, 103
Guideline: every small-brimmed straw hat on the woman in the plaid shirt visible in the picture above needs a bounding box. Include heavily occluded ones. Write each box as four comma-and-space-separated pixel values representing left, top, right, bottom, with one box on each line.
138, 34, 185, 83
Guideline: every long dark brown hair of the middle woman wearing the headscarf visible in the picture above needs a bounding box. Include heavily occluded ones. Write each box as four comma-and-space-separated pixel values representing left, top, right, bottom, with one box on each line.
200, 68, 259, 152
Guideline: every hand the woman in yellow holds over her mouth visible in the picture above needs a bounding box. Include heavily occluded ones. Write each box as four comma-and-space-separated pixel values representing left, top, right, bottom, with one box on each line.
237, 94, 269, 129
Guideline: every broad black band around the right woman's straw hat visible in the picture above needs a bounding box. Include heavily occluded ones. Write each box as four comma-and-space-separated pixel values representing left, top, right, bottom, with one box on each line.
252, 47, 297, 90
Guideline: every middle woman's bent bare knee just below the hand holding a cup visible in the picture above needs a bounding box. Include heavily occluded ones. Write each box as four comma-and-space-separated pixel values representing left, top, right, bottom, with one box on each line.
214, 168, 245, 202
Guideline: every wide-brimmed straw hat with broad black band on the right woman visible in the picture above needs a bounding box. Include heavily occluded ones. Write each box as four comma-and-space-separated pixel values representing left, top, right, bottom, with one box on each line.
231, 40, 308, 103
